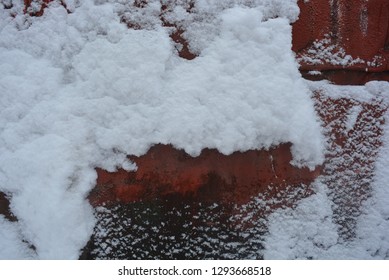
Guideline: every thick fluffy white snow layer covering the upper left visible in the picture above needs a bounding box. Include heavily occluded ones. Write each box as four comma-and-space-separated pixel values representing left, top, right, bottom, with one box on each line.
0, 0, 323, 259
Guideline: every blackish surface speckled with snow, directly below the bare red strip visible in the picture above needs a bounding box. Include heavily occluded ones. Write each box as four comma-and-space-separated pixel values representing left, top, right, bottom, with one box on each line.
88, 185, 310, 260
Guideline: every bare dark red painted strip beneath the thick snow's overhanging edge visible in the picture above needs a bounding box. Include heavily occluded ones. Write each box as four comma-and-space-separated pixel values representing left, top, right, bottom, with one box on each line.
89, 144, 320, 205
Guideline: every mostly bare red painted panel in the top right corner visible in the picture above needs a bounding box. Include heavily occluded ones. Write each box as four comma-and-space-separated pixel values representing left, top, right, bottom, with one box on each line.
293, 0, 389, 73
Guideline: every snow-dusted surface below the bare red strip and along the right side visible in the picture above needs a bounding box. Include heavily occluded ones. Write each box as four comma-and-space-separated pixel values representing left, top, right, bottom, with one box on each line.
89, 82, 389, 259
